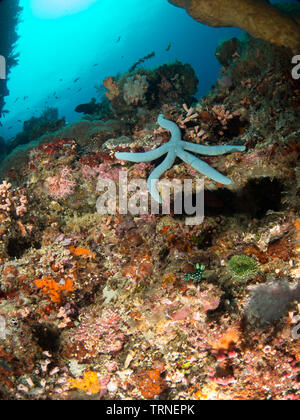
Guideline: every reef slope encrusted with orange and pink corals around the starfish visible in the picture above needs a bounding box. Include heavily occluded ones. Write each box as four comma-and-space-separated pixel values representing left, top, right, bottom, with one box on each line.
0, 37, 300, 400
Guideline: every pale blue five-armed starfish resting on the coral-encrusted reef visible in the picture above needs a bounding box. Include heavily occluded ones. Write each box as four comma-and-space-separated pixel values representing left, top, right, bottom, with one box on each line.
115, 114, 246, 203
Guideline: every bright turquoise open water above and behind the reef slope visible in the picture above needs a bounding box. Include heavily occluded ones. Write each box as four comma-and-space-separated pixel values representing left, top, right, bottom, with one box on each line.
0, 0, 296, 139
